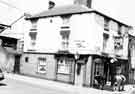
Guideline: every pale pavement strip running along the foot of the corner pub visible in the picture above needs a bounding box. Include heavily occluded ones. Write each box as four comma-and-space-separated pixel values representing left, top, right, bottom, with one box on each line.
4, 73, 135, 94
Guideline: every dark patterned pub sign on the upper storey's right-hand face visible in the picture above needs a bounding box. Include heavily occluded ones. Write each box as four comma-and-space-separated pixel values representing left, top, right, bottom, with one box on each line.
114, 36, 123, 50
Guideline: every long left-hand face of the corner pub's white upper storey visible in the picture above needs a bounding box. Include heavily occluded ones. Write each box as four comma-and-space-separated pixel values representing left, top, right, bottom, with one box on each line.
24, 13, 101, 54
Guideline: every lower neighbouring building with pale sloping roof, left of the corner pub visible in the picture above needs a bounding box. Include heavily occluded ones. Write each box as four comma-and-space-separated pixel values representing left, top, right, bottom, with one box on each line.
0, 14, 29, 73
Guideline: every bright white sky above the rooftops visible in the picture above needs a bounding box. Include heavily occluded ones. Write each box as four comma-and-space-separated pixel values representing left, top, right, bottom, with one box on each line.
0, 0, 135, 26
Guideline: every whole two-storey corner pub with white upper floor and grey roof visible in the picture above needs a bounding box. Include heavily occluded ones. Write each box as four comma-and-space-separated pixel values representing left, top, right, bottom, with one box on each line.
20, 5, 130, 87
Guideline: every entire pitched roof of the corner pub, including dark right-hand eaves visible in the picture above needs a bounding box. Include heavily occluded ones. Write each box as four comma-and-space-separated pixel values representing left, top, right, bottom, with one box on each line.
26, 4, 131, 27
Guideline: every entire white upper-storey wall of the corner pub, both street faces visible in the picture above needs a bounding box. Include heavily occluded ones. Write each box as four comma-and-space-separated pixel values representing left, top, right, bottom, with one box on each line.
24, 12, 129, 57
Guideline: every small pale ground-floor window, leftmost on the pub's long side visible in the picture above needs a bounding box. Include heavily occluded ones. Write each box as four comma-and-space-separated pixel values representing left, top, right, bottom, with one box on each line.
38, 57, 46, 74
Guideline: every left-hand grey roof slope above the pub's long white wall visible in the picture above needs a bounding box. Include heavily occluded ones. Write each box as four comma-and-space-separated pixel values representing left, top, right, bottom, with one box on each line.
26, 5, 94, 19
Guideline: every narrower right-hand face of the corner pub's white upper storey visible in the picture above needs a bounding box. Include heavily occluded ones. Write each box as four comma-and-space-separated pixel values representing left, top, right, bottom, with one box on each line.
94, 14, 131, 58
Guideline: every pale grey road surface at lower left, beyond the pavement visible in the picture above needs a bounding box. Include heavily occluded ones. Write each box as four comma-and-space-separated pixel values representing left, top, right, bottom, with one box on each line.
0, 78, 73, 94
